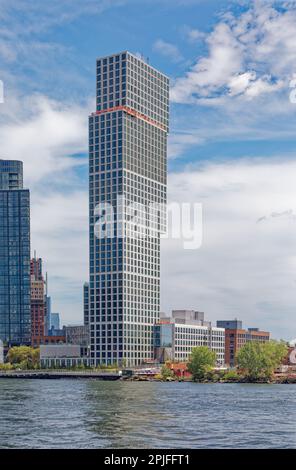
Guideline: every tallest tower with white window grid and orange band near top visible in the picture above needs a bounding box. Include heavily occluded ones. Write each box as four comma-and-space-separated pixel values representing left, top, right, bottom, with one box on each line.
89, 52, 169, 365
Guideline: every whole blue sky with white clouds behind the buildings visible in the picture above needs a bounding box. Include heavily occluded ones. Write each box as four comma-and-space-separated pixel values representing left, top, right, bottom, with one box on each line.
0, 0, 296, 339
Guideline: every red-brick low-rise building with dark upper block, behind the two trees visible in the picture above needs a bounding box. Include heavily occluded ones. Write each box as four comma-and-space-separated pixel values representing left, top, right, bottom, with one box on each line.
217, 319, 270, 367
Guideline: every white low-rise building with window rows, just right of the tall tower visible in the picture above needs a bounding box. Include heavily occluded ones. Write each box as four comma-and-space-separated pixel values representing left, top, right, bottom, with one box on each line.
154, 310, 225, 366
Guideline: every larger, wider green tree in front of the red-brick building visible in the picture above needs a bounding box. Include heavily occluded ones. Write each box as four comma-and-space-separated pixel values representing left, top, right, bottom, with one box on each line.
237, 340, 288, 381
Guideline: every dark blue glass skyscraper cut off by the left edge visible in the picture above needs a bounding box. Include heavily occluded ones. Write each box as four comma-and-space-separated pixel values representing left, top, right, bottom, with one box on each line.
0, 160, 31, 345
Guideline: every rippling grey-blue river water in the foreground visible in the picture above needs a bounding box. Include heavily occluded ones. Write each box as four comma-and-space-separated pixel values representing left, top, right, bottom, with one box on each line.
0, 379, 296, 449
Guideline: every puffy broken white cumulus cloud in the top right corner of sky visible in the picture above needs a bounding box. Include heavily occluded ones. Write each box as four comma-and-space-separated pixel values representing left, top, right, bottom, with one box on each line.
171, 0, 296, 103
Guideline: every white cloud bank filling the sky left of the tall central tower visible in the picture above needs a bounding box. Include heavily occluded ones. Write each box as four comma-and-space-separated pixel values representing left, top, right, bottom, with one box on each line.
0, 95, 90, 323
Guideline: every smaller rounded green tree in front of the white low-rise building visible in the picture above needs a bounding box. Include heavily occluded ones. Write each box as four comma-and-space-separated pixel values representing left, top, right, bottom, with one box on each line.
187, 346, 216, 382
